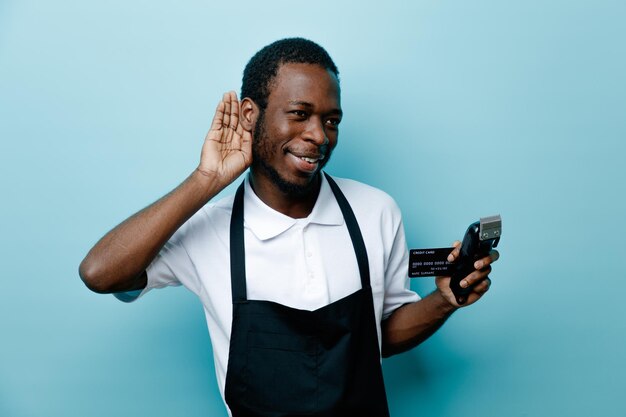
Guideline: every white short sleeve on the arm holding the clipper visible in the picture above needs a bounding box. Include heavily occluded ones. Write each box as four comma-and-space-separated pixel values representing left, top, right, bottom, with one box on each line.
382, 202, 420, 320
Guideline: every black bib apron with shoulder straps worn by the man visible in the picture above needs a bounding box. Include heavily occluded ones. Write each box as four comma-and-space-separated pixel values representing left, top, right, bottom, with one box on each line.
225, 174, 389, 417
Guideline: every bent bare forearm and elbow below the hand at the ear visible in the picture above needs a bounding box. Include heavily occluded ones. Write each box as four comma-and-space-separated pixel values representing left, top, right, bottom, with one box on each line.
79, 170, 224, 293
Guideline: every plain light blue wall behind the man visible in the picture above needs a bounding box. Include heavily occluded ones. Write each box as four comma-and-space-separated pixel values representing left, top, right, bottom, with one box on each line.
0, 0, 626, 417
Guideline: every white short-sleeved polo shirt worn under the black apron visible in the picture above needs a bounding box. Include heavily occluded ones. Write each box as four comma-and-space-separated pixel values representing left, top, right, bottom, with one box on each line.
116, 172, 419, 406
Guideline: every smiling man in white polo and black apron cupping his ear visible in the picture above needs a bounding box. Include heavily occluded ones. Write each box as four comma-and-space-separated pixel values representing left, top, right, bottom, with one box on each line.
80, 38, 498, 416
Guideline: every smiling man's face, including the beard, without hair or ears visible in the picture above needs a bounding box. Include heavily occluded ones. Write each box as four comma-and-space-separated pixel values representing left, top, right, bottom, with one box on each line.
252, 63, 342, 195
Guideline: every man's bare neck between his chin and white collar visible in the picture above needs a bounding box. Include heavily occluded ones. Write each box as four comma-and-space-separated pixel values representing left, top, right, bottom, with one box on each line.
250, 170, 322, 219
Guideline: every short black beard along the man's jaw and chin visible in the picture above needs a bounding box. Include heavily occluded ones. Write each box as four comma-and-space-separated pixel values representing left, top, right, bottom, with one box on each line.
252, 110, 331, 197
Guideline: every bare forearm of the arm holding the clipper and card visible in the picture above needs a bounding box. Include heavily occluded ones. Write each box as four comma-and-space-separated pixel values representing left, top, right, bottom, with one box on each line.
382, 290, 456, 357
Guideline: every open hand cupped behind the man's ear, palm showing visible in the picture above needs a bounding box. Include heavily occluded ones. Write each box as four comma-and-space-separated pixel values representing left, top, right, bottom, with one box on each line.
198, 91, 252, 186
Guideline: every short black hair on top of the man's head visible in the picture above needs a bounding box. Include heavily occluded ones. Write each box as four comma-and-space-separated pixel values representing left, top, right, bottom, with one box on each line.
241, 38, 339, 111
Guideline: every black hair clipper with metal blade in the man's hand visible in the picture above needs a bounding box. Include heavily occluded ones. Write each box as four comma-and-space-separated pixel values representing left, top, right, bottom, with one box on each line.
450, 214, 502, 304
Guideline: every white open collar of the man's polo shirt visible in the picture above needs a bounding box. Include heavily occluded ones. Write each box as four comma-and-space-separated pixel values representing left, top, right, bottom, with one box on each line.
243, 175, 344, 240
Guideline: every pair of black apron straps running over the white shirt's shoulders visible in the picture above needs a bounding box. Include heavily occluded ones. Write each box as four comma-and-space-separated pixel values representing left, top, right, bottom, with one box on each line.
230, 172, 370, 303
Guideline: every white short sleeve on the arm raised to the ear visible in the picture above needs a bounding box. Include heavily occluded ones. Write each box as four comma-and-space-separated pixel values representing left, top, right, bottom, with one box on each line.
113, 215, 199, 303
